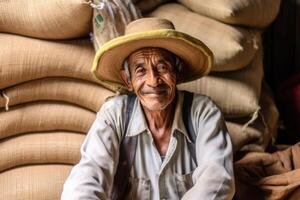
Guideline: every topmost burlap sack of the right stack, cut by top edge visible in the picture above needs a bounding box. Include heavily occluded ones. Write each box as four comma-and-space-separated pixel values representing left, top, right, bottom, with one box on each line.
177, 0, 281, 28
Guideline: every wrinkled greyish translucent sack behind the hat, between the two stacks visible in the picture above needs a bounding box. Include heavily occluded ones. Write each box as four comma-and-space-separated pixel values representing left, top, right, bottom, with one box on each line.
90, 0, 142, 50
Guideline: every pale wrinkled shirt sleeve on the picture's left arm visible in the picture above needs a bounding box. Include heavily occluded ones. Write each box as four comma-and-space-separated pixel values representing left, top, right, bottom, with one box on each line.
61, 97, 122, 200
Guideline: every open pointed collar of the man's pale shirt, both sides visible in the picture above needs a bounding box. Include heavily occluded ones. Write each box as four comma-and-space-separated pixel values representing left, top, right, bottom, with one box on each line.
126, 91, 191, 141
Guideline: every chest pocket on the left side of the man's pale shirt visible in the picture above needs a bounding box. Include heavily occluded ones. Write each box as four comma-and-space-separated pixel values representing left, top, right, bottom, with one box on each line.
126, 177, 151, 200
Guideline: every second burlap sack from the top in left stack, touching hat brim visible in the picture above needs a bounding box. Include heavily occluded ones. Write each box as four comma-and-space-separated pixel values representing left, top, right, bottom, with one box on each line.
0, 33, 113, 89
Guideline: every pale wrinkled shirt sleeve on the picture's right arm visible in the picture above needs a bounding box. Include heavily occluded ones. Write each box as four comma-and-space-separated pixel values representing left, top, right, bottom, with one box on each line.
183, 98, 235, 200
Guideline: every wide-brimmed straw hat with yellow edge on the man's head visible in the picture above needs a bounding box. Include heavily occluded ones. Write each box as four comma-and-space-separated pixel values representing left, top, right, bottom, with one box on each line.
92, 18, 213, 91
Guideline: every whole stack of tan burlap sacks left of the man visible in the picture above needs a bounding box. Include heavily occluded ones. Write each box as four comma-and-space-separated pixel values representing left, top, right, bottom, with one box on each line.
0, 0, 118, 200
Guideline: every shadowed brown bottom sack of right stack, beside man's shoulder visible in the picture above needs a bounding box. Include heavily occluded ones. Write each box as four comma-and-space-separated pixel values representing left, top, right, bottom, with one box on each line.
226, 84, 279, 152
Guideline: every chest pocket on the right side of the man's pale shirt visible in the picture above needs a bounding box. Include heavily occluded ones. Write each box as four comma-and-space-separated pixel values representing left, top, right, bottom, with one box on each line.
175, 172, 194, 198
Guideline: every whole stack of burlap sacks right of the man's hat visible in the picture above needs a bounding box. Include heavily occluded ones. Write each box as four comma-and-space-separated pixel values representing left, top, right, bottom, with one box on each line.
147, 0, 280, 152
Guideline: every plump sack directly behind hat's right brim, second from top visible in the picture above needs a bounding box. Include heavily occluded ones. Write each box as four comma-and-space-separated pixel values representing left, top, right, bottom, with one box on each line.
150, 3, 260, 71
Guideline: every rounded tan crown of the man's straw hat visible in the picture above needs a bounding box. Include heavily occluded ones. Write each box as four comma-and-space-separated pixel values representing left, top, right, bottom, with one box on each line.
125, 17, 175, 35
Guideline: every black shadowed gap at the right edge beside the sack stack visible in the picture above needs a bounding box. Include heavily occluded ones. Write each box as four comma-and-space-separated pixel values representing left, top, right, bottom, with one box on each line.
263, 0, 300, 144
